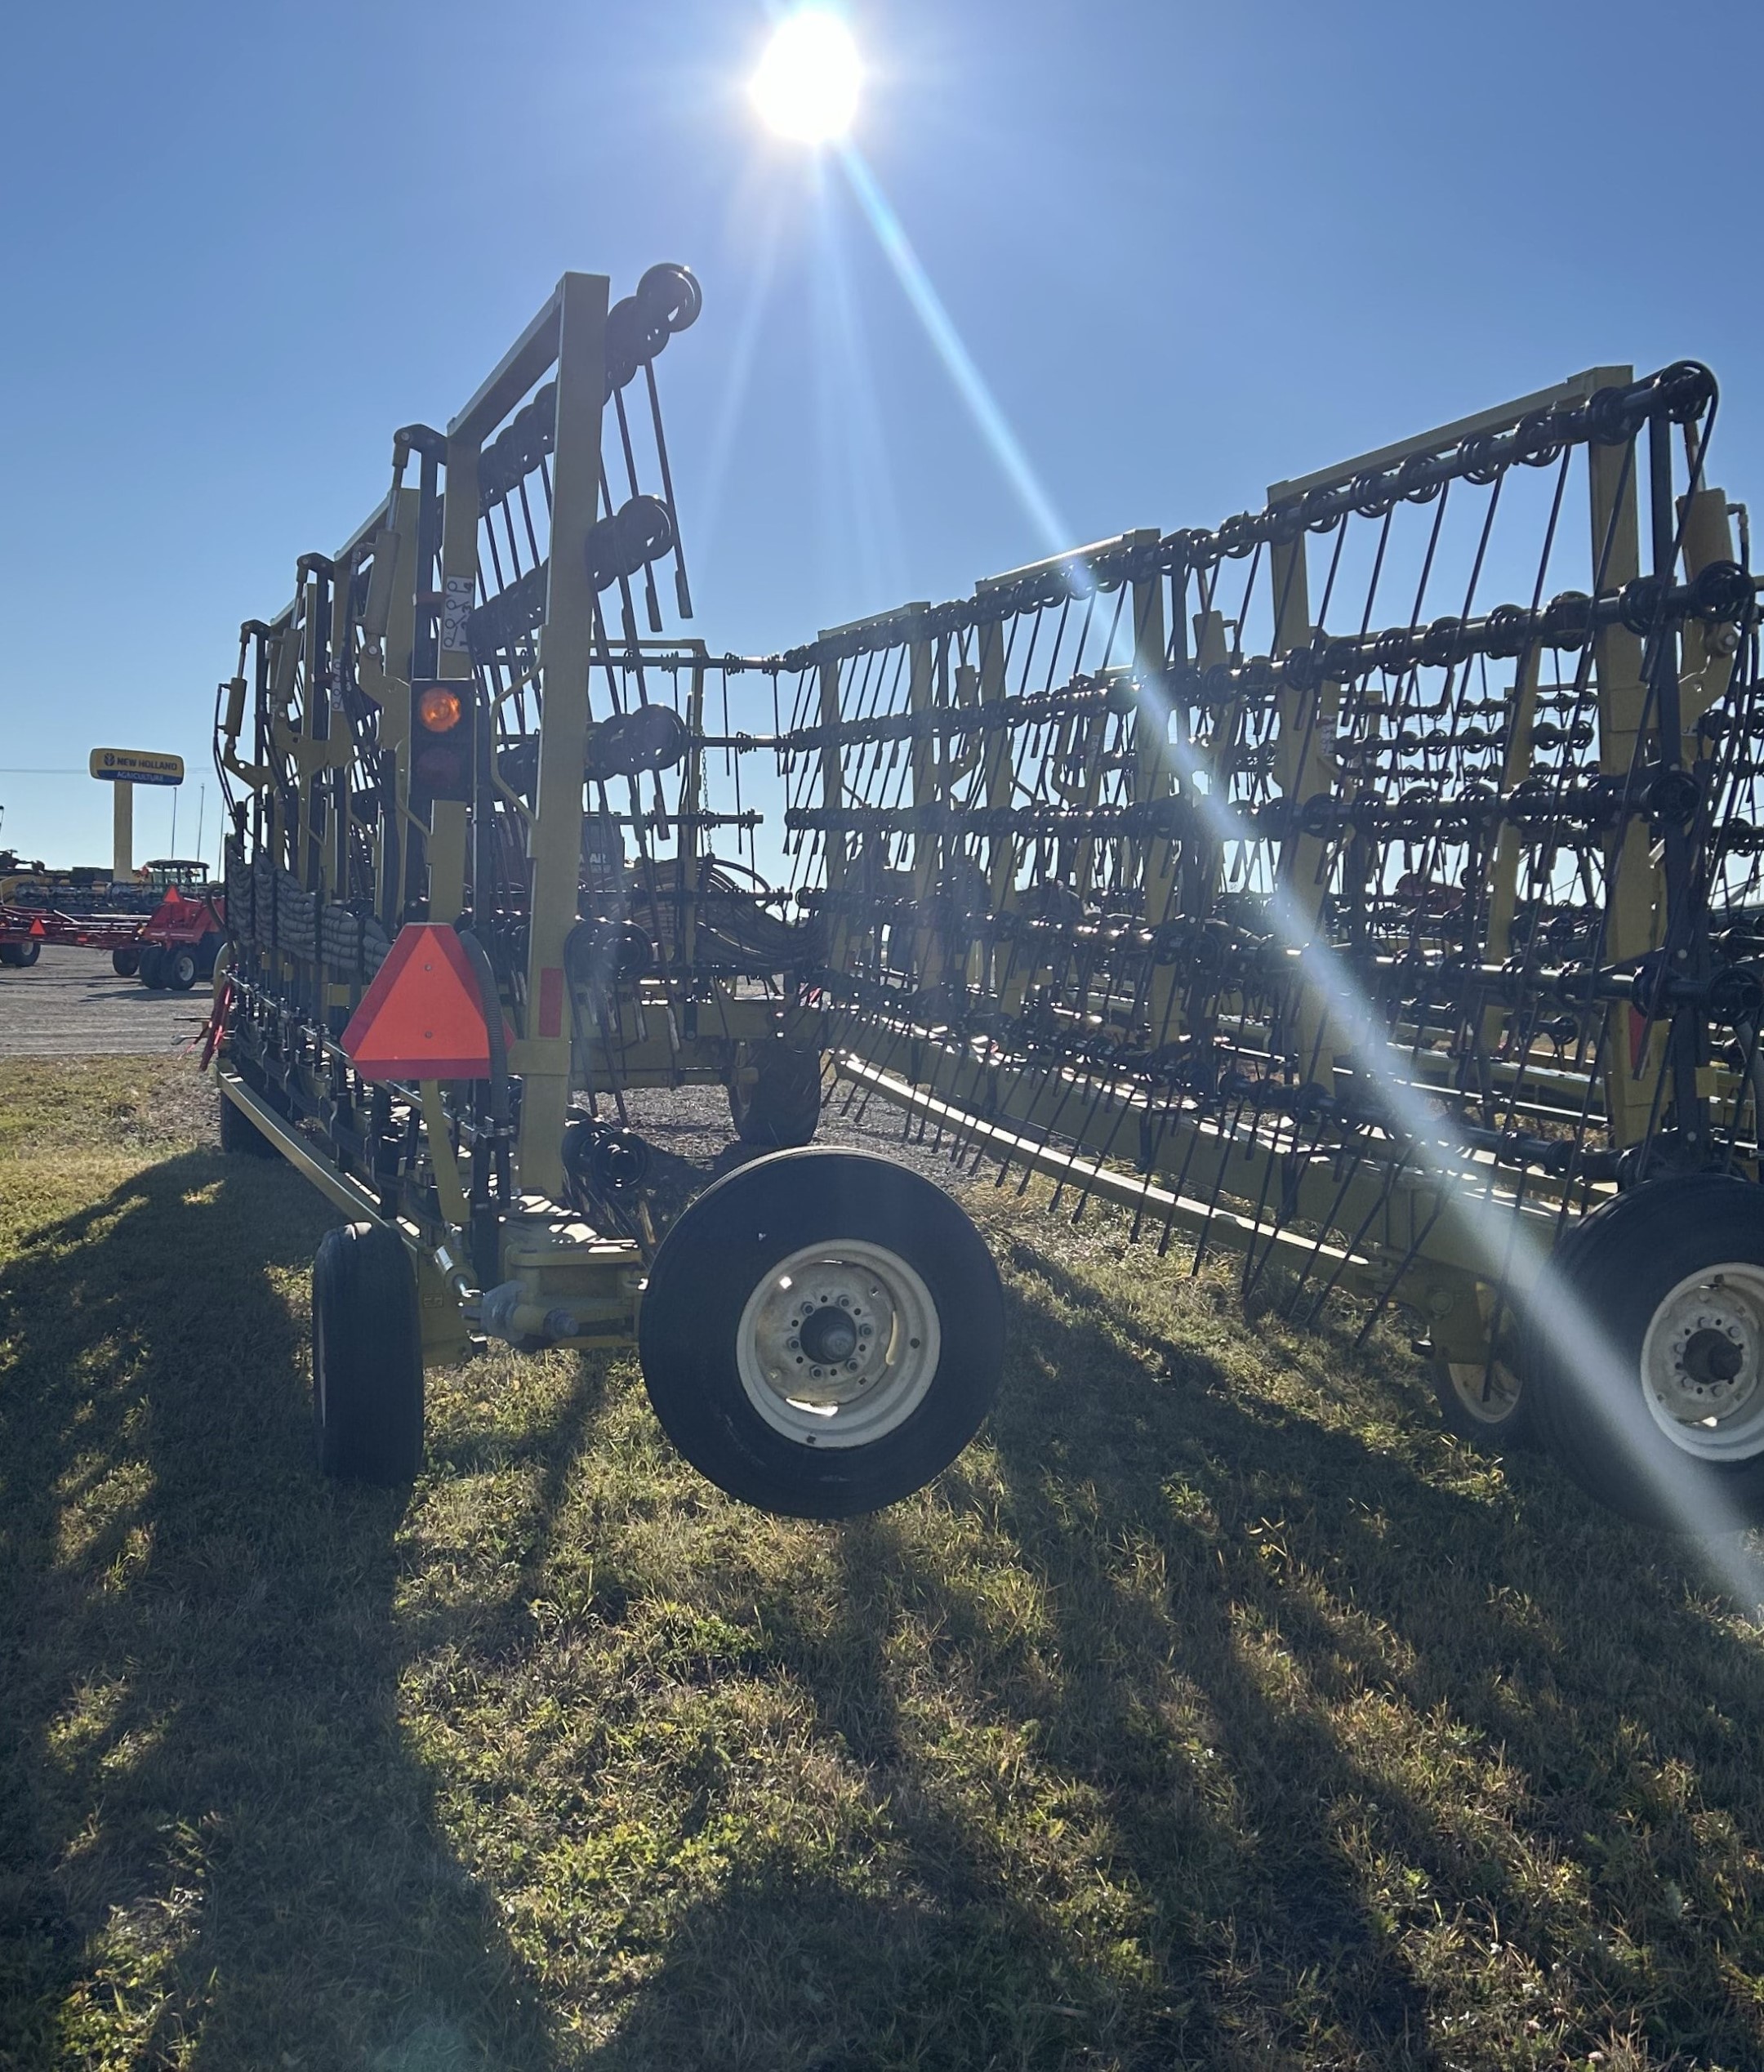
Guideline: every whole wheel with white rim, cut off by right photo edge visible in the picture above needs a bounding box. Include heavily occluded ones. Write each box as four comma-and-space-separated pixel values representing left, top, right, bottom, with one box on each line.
1524, 1173, 1764, 1533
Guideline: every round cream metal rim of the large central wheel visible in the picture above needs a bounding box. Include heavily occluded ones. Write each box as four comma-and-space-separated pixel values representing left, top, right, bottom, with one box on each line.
736, 1237, 943, 1446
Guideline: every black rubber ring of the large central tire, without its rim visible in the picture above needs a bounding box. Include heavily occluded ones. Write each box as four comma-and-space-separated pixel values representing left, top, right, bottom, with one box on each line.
639, 1150, 1003, 1519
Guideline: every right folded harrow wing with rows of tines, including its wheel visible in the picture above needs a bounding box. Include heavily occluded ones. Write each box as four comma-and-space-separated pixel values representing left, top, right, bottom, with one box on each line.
779, 363, 1764, 1525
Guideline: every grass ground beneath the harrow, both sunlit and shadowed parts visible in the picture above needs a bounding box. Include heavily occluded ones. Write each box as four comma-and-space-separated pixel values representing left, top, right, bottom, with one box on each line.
0, 1061, 1764, 2072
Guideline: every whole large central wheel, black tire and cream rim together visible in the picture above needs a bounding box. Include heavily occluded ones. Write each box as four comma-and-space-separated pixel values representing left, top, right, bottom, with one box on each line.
639, 1150, 1005, 1519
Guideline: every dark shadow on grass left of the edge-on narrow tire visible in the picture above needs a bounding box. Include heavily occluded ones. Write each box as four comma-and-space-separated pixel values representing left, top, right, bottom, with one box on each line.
0, 1152, 555, 2072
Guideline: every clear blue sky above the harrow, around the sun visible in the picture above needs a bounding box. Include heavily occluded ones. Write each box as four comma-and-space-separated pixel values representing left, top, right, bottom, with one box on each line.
0, 0, 1764, 864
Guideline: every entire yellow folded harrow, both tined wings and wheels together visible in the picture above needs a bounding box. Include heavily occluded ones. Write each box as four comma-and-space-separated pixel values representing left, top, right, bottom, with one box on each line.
218, 267, 1764, 1523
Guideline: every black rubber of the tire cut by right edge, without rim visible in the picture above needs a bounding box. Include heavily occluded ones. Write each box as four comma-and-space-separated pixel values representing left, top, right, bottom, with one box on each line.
1524, 1173, 1764, 1533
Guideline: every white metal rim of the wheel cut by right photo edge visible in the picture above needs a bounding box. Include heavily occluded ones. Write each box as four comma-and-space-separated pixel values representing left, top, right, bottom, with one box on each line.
1642, 1262, 1764, 1461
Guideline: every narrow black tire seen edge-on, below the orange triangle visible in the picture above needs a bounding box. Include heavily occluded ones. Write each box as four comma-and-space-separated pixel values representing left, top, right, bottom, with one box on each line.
313, 1223, 423, 1488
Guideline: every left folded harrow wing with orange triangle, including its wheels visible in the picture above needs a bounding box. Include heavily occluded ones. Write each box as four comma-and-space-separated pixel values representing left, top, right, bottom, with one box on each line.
216, 265, 1003, 1517
